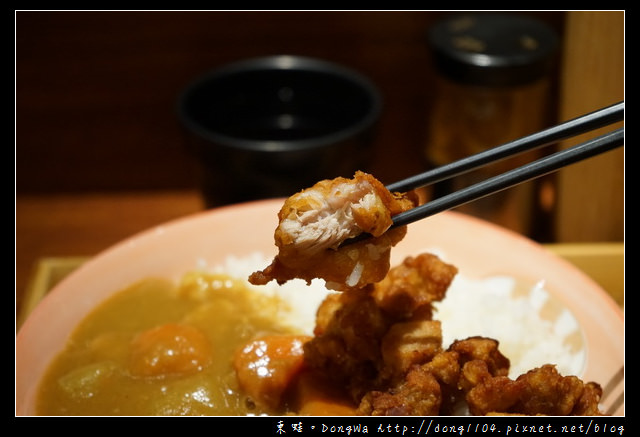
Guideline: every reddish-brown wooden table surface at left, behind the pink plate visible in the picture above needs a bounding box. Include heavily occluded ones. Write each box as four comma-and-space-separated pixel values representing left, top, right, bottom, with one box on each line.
15, 187, 203, 324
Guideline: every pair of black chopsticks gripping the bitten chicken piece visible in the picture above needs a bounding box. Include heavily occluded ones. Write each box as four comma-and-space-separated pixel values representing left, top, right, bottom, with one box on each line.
343, 101, 624, 244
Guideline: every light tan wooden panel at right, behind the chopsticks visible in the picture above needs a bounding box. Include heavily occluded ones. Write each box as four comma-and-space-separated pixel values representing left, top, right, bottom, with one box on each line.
556, 11, 625, 242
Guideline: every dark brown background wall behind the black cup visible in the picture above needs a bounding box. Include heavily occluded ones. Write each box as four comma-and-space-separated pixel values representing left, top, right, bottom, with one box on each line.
16, 11, 563, 193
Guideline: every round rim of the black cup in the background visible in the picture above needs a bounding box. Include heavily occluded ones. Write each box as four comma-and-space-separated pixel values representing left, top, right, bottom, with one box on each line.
177, 55, 382, 153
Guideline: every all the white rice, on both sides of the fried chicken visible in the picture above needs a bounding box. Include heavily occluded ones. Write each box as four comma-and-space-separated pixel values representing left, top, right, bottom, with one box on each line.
200, 250, 586, 378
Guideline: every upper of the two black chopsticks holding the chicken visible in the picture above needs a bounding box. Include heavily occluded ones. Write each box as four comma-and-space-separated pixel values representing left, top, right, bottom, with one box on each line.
387, 101, 624, 192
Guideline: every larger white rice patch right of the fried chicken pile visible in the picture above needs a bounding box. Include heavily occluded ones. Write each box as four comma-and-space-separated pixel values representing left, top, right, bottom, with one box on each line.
434, 275, 585, 378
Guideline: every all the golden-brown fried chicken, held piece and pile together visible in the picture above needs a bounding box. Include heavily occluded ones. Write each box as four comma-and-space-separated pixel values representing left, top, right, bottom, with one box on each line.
244, 172, 602, 416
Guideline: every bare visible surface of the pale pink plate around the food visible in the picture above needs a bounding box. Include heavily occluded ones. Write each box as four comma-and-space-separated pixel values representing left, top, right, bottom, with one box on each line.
16, 200, 624, 415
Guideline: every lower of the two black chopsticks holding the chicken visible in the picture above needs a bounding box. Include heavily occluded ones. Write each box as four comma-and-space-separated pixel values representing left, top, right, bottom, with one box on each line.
392, 127, 624, 228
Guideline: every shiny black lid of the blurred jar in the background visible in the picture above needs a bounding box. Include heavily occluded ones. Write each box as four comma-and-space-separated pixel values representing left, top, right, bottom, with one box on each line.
429, 13, 558, 85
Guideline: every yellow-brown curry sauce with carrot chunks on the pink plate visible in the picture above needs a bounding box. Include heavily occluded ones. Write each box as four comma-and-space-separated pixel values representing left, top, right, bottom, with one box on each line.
37, 273, 304, 415
